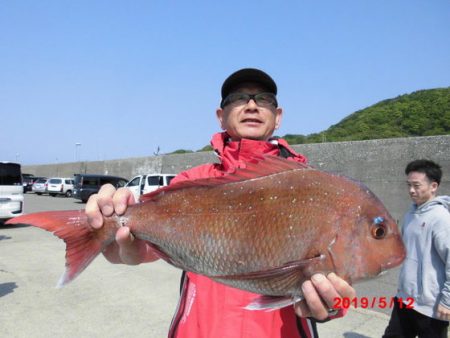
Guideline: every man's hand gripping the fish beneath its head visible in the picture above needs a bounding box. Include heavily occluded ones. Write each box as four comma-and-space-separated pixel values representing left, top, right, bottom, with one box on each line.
295, 273, 356, 320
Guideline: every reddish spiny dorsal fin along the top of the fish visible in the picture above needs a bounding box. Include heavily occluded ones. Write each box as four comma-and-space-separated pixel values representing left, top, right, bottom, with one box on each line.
140, 155, 311, 202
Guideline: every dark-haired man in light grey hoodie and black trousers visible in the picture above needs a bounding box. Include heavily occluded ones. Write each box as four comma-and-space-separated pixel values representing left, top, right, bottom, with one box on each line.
383, 160, 450, 338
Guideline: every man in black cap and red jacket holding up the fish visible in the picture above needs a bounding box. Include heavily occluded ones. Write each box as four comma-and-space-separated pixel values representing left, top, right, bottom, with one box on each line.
86, 68, 355, 338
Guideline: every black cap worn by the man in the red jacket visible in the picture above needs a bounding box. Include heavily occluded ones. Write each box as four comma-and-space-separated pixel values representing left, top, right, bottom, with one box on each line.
222, 68, 277, 101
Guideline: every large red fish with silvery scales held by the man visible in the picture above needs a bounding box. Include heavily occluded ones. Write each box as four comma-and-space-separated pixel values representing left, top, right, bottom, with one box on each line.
8, 157, 405, 308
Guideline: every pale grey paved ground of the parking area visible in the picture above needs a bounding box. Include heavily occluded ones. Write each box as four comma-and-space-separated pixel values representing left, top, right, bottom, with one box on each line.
0, 193, 414, 338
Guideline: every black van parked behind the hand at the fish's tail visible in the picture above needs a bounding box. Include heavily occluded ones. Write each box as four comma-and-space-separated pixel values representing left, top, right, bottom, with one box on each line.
73, 174, 128, 203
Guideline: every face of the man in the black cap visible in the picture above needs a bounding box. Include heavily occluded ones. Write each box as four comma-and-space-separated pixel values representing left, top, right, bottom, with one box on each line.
217, 83, 282, 141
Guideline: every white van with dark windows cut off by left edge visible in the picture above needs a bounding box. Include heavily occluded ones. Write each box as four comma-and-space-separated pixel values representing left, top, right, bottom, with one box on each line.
0, 162, 23, 220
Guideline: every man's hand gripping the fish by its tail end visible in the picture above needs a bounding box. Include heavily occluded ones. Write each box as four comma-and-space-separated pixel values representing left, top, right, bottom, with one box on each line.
85, 184, 158, 265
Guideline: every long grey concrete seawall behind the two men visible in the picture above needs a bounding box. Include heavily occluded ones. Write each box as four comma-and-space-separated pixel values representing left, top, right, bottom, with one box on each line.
23, 135, 450, 219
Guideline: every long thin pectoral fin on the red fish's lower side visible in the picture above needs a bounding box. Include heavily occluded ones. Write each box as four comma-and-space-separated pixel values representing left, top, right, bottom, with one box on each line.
214, 254, 325, 280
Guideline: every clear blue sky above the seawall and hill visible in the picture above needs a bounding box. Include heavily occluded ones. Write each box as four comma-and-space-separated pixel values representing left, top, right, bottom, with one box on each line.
0, 0, 450, 164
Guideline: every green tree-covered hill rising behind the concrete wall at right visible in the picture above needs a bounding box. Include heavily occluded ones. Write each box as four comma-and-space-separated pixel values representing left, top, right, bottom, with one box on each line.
284, 87, 450, 144
